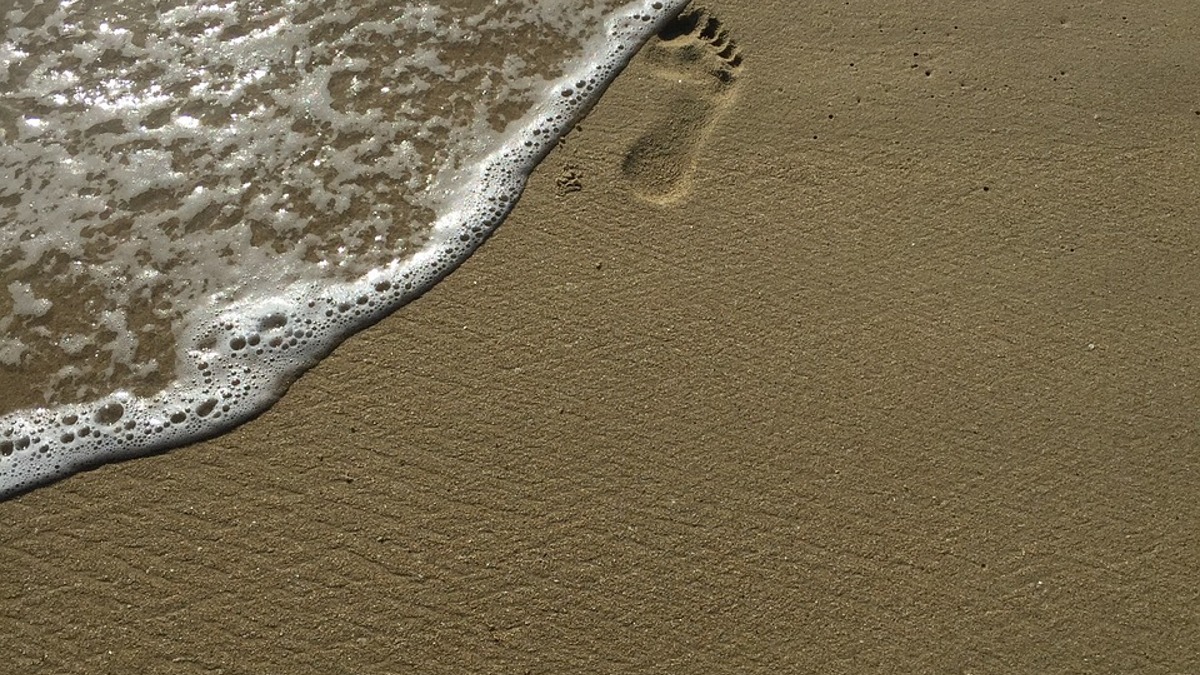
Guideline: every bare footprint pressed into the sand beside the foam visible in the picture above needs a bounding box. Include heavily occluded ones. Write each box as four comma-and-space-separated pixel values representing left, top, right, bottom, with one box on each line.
622, 8, 742, 203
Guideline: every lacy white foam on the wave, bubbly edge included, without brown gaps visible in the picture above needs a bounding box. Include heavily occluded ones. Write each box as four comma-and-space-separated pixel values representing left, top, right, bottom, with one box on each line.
0, 0, 685, 497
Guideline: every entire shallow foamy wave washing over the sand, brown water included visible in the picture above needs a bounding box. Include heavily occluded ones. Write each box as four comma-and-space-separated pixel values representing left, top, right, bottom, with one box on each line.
0, 0, 685, 498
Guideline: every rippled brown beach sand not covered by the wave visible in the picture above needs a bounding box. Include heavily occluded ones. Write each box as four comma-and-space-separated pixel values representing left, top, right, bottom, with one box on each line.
0, 0, 1200, 674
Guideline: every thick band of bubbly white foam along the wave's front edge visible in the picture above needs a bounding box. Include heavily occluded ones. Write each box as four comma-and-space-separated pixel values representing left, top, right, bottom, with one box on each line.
0, 0, 688, 500
